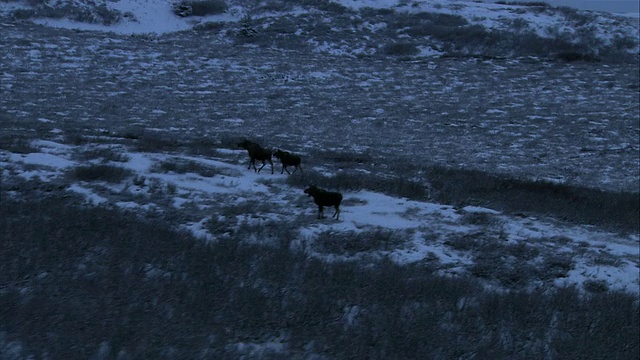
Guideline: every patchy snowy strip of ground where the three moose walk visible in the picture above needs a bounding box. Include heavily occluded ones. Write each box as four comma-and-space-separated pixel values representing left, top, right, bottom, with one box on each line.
0, 141, 640, 293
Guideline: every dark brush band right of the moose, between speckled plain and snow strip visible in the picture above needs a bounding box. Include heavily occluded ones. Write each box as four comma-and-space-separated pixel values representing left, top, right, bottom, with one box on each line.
425, 166, 640, 232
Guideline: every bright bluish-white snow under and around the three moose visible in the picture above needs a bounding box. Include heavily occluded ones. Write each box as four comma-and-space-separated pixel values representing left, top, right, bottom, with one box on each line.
3, 141, 640, 293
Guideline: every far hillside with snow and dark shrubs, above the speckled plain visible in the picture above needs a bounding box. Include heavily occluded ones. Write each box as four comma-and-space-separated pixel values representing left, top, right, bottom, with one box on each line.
4, 0, 638, 61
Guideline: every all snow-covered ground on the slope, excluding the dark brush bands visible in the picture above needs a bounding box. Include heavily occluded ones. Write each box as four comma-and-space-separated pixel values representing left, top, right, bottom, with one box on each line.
0, 0, 640, 293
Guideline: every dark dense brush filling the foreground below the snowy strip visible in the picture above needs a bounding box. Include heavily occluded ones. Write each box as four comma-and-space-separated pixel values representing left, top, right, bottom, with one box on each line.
0, 196, 640, 359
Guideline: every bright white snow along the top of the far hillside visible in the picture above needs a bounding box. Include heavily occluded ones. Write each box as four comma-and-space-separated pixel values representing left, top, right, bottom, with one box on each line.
0, 0, 638, 37
